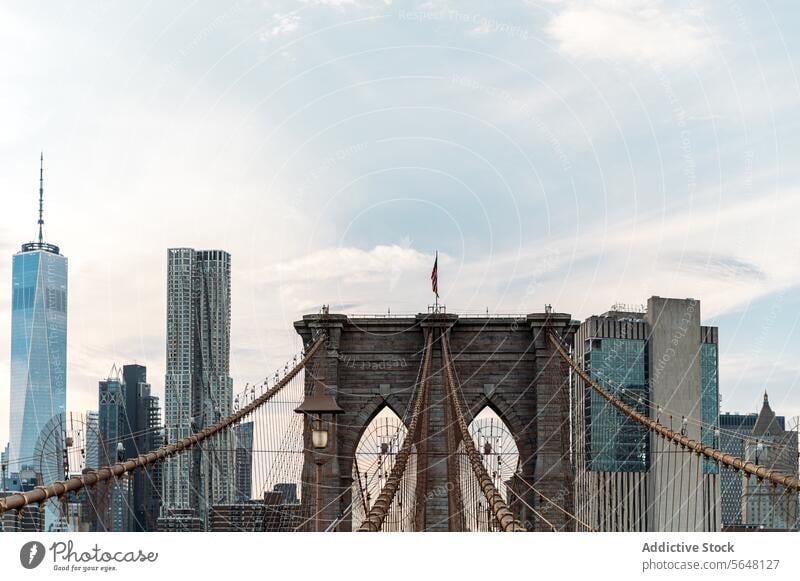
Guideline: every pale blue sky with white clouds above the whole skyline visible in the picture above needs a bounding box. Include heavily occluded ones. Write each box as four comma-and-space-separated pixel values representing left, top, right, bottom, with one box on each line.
0, 0, 800, 442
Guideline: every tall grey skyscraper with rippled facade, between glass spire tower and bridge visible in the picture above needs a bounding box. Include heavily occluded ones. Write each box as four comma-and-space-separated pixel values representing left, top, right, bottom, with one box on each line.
162, 248, 234, 527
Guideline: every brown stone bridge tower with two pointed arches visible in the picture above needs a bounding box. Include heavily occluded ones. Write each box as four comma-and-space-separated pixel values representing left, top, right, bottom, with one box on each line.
294, 312, 577, 531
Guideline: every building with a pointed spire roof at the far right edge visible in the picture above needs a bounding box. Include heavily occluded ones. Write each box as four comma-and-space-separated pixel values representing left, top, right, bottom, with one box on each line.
742, 393, 800, 530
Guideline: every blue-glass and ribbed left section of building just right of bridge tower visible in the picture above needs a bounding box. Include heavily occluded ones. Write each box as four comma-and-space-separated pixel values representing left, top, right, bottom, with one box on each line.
573, 311, 651, 531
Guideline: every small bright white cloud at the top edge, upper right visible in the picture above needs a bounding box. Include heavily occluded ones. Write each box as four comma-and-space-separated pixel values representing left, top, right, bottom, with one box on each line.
546, 0, 710, 65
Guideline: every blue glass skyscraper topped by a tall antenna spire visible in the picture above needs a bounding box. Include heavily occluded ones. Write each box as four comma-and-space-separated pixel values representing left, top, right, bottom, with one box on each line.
8, 153, 67, 473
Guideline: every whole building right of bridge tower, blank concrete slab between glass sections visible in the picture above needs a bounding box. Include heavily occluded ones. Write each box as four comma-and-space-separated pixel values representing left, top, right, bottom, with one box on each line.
573, 297, 721, 531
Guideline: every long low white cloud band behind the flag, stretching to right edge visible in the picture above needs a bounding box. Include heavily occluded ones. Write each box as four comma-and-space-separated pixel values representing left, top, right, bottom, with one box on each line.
256, 182, 800, 326
